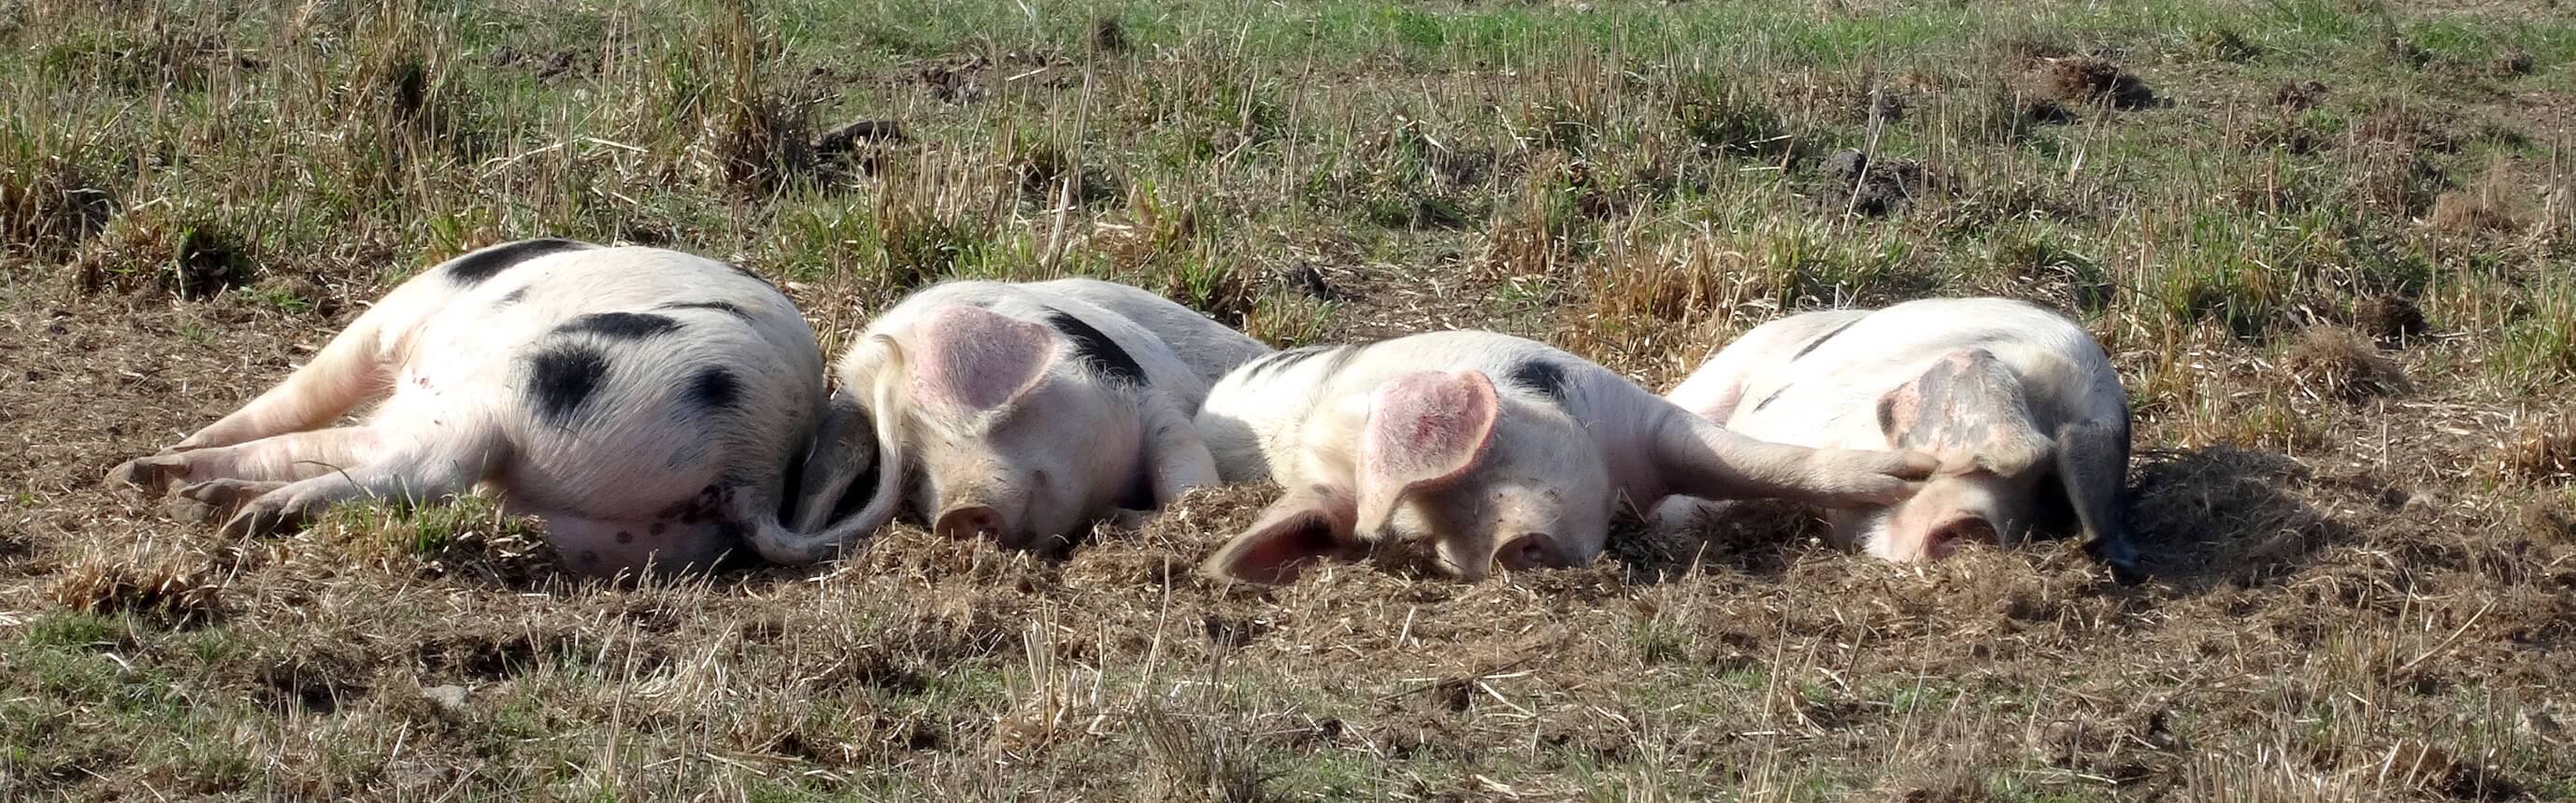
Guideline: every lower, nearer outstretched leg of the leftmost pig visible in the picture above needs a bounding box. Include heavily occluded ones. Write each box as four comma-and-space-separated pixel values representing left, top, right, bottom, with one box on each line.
224, 429, 502, 538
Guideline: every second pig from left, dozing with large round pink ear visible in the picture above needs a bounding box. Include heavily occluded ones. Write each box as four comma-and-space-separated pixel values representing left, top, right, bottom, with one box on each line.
755, 278, 1270, 564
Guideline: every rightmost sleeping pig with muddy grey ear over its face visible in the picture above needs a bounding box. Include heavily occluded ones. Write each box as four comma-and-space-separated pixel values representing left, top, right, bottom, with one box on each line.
1659, 298, 2138, 579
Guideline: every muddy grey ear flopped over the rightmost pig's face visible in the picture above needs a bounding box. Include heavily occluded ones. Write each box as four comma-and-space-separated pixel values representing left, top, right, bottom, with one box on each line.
1878, 348, 2051, 476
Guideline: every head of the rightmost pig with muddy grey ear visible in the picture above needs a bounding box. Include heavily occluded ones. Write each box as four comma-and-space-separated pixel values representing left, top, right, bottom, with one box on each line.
1844, 350, 2054, 561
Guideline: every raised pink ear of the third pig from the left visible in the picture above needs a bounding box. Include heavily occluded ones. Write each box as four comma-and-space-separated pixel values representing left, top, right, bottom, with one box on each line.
1357, 370, 1499, 533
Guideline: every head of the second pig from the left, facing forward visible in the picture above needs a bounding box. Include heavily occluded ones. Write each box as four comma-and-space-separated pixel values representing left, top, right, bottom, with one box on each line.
809, 304, 1144, 548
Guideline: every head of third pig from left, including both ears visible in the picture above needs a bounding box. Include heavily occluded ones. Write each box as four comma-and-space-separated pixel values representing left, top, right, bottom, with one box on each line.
1209, 370, 1610, 581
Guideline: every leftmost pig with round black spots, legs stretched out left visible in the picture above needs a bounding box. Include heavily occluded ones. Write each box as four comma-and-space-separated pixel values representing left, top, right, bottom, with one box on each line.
111, 239, 824, 574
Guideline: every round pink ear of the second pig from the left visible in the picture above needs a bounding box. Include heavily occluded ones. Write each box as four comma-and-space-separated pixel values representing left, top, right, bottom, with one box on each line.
902, 304, 1056, 412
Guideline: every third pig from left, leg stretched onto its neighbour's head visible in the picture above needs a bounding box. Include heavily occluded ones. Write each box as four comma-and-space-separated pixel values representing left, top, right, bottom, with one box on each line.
1198, 332, 1932, 581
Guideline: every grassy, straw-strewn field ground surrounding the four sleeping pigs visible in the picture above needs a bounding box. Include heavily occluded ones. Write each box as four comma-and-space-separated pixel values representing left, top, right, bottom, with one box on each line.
0, 0, 2576, 800
